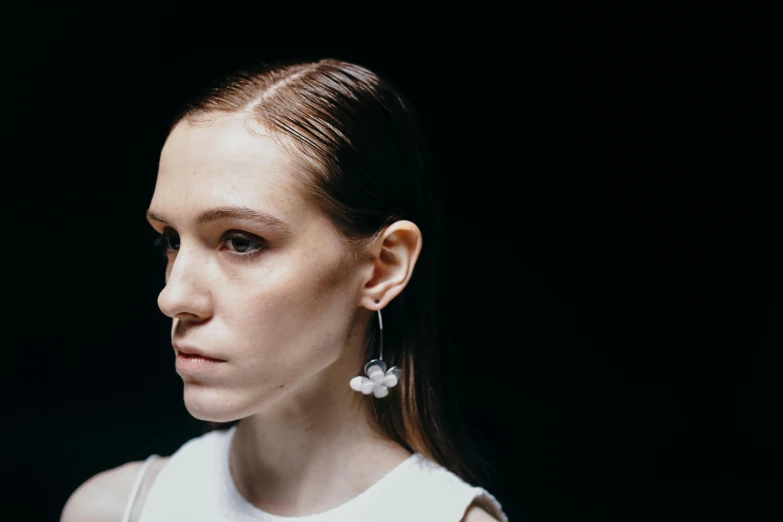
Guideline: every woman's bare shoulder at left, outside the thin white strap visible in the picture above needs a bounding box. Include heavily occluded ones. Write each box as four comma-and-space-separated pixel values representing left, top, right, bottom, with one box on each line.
60, 458, 172, 522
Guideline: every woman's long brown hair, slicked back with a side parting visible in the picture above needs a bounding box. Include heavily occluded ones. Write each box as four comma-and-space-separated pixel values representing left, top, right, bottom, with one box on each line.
169, 59, 491, 484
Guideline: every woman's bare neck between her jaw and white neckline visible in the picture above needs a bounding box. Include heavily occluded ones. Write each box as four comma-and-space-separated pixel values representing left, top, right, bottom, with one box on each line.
229, 340, 410, 516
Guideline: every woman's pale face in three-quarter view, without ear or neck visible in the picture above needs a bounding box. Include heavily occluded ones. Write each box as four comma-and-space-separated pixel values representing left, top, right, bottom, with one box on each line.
149, 116, 368, 422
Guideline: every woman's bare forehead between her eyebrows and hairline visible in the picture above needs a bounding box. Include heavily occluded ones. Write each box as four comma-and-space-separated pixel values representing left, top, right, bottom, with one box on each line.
150, 115, 312, 219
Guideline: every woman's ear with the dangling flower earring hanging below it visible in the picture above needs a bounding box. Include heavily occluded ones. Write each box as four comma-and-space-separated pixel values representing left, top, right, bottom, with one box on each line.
359, 220, 422, 310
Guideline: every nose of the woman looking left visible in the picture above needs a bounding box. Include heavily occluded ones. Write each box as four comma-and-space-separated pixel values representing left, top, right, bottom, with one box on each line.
158, 247, 210, 319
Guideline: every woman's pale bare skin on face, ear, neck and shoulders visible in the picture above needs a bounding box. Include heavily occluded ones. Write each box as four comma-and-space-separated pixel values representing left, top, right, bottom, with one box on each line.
61, 115, 496, 522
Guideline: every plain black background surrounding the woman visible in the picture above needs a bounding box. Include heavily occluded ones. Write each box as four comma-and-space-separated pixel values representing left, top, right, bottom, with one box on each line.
9, 2, 783, 521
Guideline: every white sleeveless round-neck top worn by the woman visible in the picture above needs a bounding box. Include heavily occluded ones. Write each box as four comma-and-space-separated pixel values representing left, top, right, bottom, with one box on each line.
123, 426, 508, 522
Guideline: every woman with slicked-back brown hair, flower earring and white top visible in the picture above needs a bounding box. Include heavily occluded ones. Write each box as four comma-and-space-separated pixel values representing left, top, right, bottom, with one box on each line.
61, 60, 506, 522
